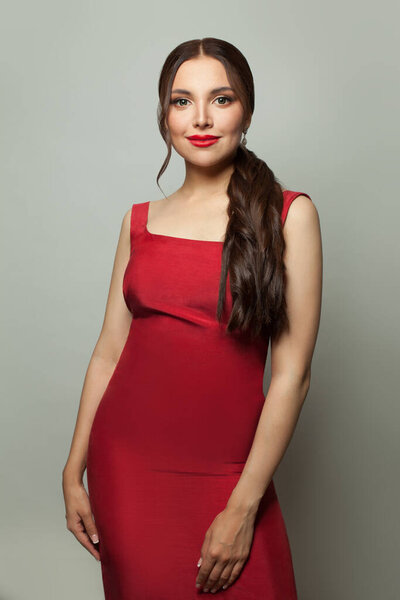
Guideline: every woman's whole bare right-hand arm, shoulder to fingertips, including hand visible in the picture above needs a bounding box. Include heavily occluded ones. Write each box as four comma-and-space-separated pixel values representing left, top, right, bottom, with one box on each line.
196, 196, 322, 590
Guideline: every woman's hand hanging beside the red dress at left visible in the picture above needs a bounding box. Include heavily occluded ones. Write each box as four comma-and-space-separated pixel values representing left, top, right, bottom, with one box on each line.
63, 478, 100, 560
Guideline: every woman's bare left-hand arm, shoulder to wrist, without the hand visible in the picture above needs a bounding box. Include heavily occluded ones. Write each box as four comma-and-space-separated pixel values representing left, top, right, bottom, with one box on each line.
63, 210, 132, 483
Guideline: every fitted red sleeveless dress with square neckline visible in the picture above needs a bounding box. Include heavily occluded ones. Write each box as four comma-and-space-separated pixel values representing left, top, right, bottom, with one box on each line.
87, 190, 309, 600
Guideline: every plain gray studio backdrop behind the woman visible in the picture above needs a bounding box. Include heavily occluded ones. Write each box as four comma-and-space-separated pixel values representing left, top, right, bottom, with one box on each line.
0, 0, 400, 600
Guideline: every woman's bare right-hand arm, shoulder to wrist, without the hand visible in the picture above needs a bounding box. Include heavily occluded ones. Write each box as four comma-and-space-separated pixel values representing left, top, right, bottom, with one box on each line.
228, 196, 322, 517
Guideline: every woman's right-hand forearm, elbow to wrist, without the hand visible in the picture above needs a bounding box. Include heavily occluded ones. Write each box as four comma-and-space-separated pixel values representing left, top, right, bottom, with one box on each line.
228, 376, 309, 515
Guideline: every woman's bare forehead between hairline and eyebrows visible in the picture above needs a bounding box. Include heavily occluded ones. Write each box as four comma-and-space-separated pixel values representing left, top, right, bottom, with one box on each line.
172, 56, 230, 92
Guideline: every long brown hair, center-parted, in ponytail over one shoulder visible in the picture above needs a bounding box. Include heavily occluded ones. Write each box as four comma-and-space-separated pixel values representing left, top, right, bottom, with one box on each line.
157, 37, 289, 339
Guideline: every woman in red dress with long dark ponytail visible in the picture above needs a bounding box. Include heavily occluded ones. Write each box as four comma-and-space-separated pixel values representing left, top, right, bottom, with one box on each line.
63, 38, 322, 600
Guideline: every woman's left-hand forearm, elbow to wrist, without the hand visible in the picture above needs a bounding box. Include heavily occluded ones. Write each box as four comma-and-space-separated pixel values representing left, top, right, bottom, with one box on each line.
63, 355, 116, 480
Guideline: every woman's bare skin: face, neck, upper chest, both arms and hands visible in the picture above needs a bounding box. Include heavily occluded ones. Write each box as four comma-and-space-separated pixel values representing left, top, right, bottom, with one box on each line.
63, 56, 322, 592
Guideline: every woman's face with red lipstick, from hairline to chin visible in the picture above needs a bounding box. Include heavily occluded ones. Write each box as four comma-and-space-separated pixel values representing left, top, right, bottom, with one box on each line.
167, 56, 248, 167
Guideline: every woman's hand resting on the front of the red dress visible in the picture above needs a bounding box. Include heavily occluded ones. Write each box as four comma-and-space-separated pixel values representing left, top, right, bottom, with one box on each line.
196, 507, 255, 592
